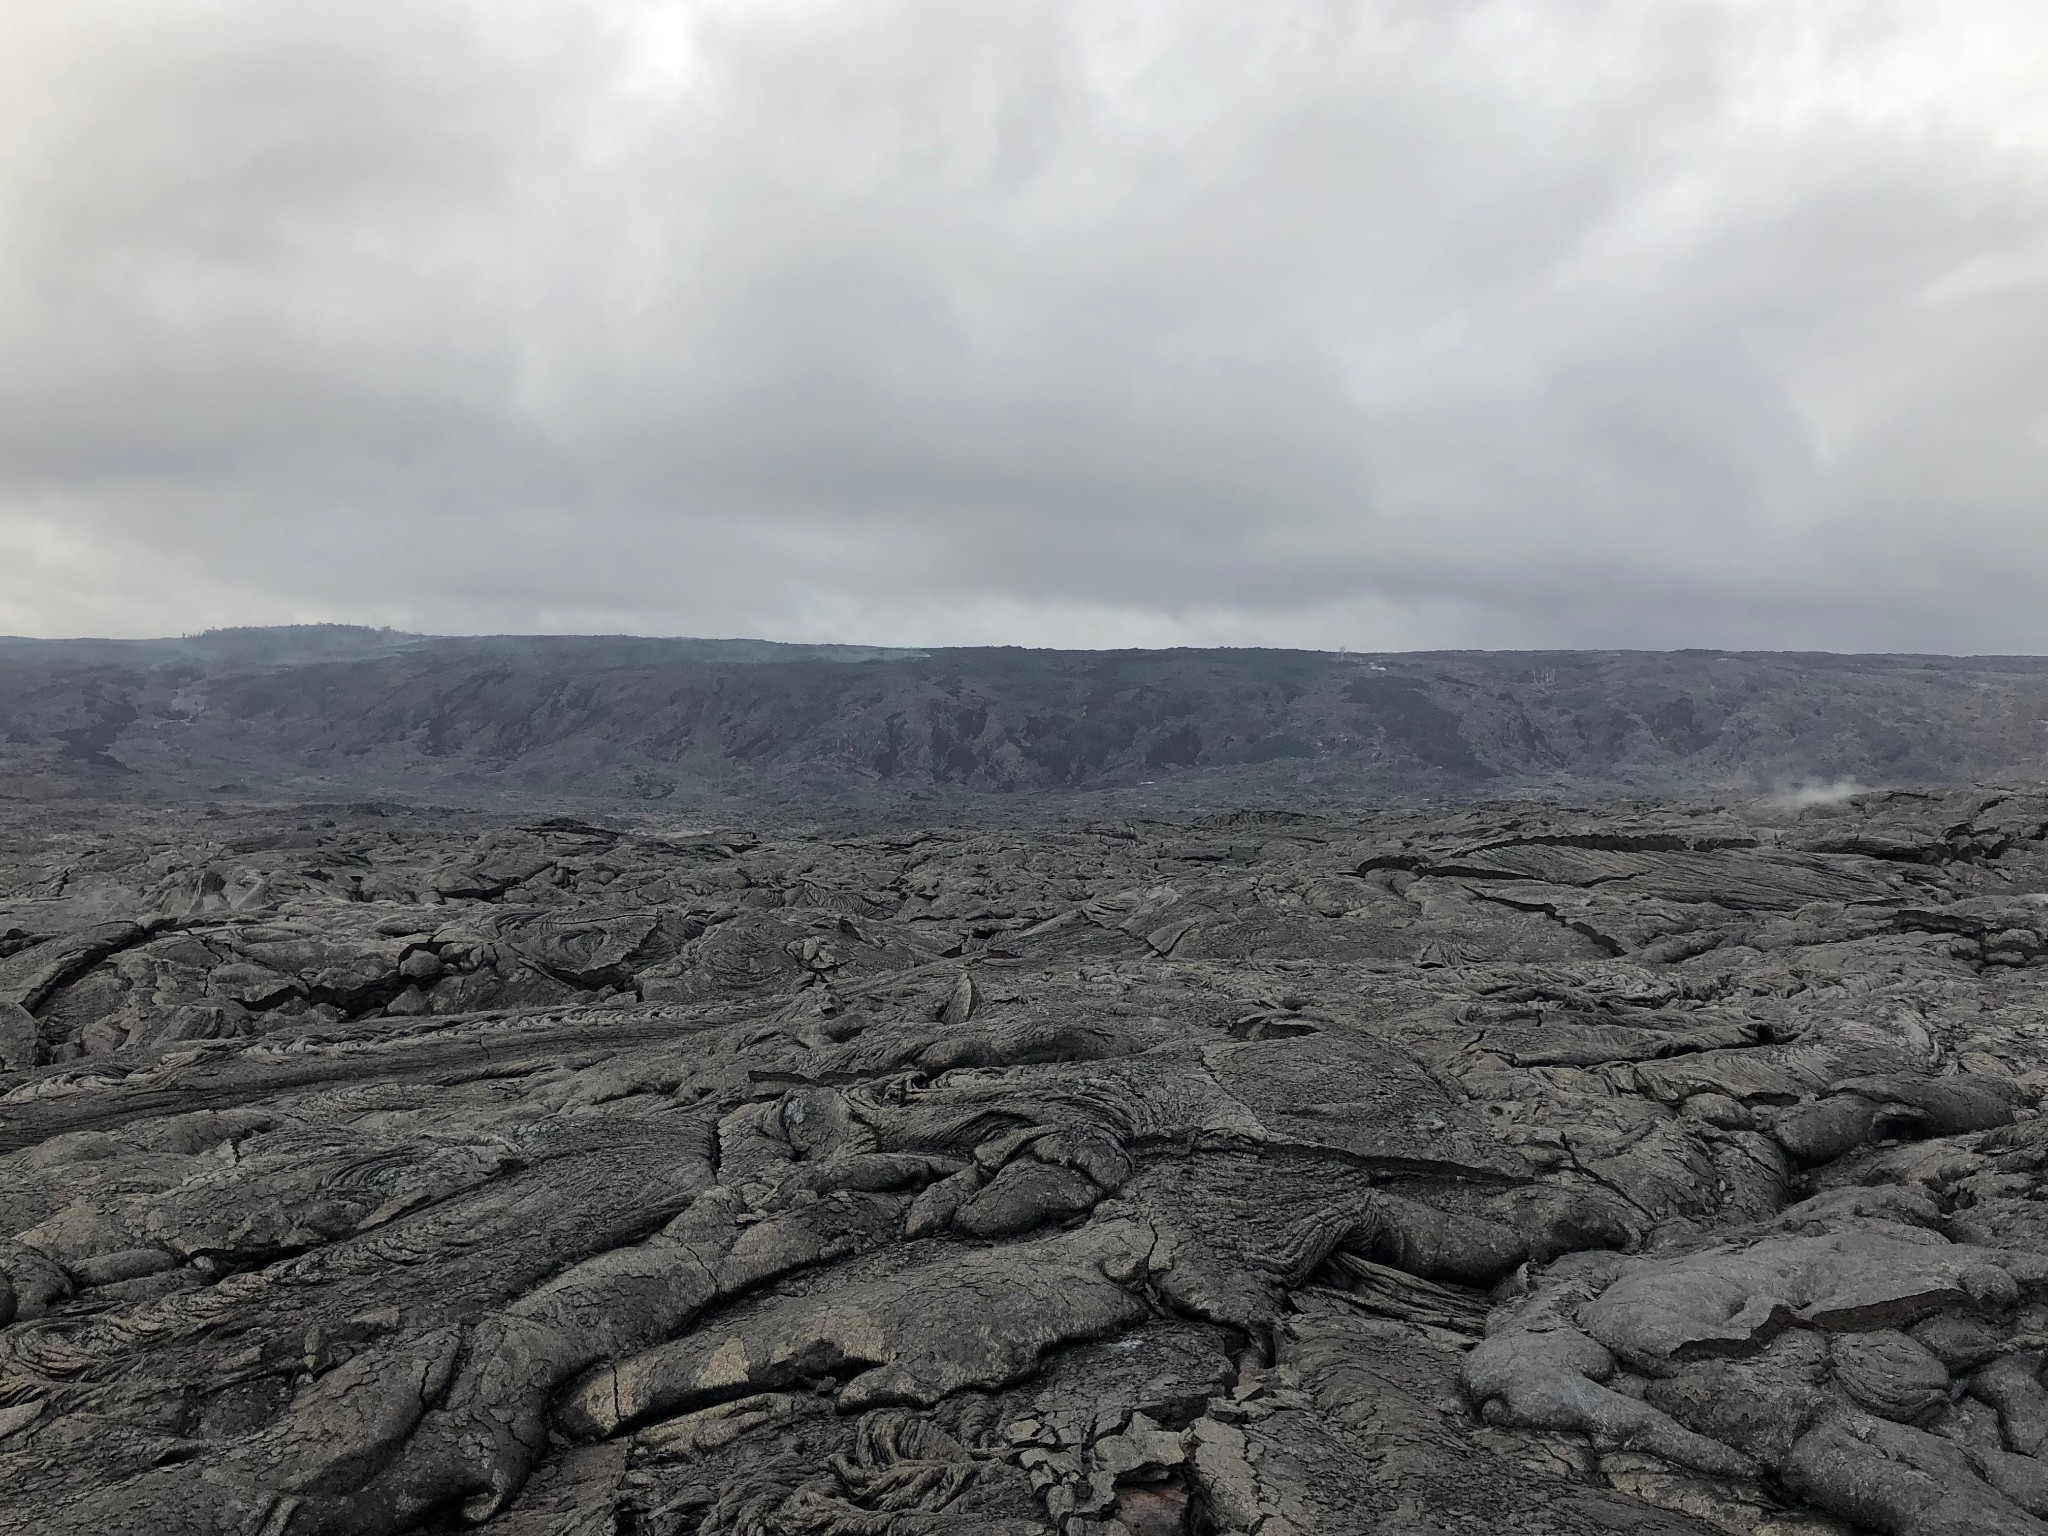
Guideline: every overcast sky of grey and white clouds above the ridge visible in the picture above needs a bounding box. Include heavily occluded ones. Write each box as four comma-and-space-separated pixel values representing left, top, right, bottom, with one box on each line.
0, 0, 2048, 651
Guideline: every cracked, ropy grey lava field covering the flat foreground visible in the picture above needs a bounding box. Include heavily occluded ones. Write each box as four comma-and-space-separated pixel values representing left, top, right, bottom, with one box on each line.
0, 786, 2048, 1536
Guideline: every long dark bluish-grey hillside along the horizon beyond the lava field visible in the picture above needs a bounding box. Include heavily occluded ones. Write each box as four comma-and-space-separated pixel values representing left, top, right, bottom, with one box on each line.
0, 627, 2048, 805
